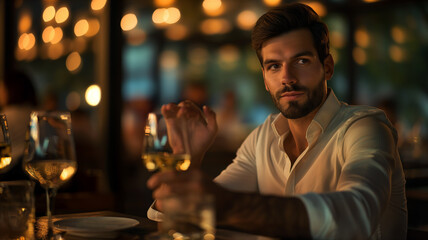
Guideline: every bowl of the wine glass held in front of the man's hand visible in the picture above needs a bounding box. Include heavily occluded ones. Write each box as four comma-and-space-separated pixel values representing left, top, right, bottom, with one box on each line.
142, 112, 191, 171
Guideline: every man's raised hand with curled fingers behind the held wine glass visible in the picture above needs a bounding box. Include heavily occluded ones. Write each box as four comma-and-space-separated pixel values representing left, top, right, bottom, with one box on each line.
161, 101, 218, 168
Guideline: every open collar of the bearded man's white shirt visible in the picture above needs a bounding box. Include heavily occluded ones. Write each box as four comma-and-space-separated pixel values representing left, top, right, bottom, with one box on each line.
272, 88, 341, 136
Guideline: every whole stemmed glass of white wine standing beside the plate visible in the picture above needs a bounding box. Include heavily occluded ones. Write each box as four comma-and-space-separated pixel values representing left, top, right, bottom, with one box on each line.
23, 112, 77, 234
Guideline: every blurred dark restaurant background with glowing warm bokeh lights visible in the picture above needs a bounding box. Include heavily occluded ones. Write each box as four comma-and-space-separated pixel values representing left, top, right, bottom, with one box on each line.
0, 0, 428, 231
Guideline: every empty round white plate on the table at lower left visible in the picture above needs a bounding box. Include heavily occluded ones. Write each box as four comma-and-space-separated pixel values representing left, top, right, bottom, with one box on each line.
54, 216, 140, 237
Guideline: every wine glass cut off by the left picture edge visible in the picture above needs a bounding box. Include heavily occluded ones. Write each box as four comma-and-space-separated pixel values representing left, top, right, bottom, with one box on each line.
0, 114, 12, 173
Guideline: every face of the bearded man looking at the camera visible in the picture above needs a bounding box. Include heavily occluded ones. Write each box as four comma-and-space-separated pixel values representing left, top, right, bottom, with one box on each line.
261, 29, 334, 119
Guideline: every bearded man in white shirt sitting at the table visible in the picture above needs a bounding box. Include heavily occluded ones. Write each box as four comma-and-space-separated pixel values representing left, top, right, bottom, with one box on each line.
147, 3, 407, 239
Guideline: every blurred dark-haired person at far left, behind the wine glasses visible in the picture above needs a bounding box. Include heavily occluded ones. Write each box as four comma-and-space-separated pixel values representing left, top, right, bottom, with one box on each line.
0, 71, 38, 180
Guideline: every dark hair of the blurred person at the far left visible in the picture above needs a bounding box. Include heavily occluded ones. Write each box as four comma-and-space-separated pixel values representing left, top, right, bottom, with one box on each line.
4, 71, 37, 106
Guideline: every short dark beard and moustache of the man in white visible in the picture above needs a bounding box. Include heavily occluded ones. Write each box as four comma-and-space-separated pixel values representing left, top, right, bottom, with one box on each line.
270, 81, 326, 119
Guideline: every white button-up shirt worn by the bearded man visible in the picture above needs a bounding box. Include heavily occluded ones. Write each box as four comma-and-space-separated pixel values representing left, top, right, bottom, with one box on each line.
215, 91, 407, 239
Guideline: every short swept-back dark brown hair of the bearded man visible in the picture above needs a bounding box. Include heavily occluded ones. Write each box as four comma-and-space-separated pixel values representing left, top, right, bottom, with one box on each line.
251, 3, 330, 66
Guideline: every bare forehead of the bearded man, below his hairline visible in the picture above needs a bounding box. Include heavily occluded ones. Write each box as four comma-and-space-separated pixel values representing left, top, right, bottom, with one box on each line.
261, 29, 318, 59
